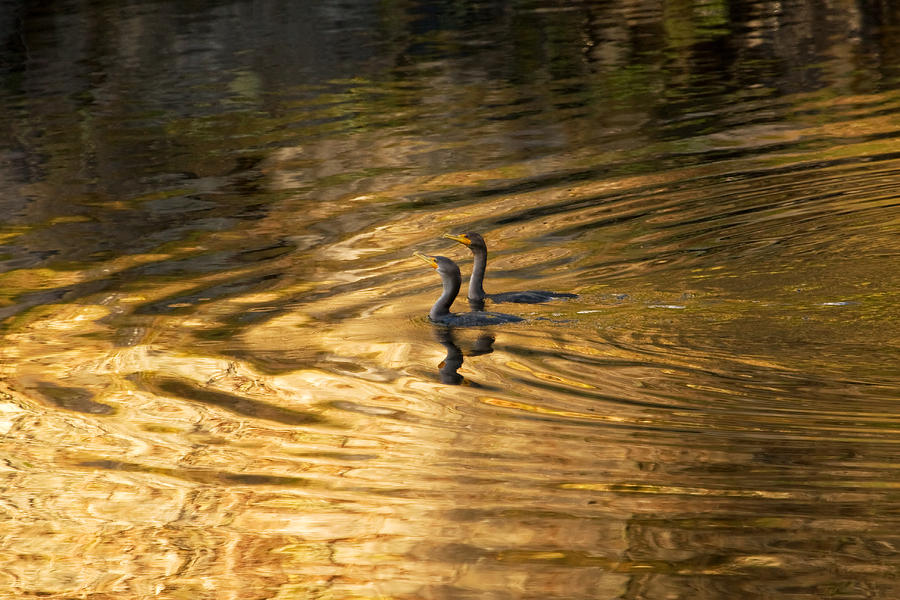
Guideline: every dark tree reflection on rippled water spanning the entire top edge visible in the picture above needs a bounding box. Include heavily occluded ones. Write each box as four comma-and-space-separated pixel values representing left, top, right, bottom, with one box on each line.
0, 0, 900, 276
